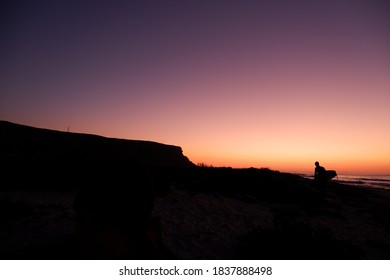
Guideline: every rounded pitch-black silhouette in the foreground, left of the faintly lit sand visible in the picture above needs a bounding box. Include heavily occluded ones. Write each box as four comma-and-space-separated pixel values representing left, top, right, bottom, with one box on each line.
74, 163, 171, 259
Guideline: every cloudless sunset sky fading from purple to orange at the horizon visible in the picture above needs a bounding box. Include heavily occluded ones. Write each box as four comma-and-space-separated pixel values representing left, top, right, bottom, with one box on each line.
0, 0, 390, 174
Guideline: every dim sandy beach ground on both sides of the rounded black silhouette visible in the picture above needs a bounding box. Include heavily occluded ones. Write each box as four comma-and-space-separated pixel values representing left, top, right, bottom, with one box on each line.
0, 167, 390, 259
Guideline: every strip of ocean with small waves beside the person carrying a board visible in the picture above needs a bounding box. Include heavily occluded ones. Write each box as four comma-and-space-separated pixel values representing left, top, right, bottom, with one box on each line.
304, 174, 390, 190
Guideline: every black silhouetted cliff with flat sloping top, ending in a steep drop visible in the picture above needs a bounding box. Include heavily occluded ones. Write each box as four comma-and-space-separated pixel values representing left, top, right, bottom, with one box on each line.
0, 121, 194, 189
